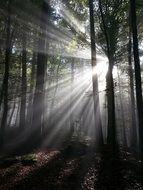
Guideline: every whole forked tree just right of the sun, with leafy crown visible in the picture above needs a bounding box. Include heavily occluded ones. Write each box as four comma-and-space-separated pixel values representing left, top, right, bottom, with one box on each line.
99, 0, 120, 146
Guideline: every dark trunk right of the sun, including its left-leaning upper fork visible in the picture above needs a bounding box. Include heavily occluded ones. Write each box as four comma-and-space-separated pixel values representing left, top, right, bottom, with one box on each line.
99, 0, 117, 149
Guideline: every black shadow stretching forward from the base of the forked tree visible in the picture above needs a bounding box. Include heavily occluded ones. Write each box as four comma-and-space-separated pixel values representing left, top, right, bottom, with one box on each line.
95, 145, 125, 190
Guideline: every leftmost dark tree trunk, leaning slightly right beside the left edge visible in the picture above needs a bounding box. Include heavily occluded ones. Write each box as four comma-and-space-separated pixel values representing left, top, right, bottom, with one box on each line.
0, 0, 11, 145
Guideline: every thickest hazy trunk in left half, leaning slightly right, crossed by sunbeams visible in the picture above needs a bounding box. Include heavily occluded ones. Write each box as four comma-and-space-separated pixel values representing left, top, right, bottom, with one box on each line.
32, 1, 49, 140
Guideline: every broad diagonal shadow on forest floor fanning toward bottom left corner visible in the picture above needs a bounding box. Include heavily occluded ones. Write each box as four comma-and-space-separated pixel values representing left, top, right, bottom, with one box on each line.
10, 143, 96, 190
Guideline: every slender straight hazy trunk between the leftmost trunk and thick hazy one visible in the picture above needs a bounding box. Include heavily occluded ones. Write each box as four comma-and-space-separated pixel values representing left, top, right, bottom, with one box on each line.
19, 31, 27, 129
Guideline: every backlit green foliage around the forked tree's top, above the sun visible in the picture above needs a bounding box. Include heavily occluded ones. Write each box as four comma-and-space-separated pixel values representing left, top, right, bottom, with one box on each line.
96, 0, 129, 60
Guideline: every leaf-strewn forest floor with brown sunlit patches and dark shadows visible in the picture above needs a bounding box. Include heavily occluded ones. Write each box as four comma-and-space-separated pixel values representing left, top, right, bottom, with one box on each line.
0, 141, 143, 190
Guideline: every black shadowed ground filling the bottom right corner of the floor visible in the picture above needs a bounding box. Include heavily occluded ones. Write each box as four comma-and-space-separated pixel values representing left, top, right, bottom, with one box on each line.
95, 145, 143, 190
